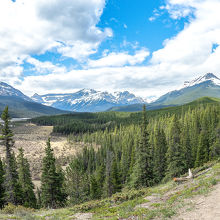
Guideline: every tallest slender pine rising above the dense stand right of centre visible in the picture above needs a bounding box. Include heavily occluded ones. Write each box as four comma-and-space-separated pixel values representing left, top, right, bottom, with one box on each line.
131, 105, 153, 188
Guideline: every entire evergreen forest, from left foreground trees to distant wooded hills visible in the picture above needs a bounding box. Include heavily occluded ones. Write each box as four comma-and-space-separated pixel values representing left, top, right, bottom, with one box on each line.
0, 98, 220, 208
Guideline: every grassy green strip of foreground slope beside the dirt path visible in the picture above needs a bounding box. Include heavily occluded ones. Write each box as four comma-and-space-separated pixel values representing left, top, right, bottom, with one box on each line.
0, 162, 220, 220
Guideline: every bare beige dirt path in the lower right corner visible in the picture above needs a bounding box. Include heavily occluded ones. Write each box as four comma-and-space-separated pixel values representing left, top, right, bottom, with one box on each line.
173, 184, 220, 220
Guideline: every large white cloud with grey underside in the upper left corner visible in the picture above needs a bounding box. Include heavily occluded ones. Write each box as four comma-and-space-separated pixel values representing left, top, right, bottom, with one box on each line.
0, 0, 112, 73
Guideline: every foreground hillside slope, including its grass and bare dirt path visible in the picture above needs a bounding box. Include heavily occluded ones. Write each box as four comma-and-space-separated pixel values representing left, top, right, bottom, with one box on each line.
0, 162, 220, 220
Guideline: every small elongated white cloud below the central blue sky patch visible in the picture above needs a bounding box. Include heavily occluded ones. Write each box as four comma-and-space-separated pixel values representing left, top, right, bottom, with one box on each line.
88, 48, 150, 67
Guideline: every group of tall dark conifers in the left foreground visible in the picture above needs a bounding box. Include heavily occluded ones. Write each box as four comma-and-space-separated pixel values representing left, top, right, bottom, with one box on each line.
0, 107, 67, 208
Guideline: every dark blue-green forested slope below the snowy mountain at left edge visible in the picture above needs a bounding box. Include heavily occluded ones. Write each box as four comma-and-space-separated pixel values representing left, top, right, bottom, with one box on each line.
0, 96, 67, 118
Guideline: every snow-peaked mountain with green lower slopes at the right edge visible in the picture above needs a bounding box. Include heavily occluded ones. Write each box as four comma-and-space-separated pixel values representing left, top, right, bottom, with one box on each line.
151, 73, 220, 105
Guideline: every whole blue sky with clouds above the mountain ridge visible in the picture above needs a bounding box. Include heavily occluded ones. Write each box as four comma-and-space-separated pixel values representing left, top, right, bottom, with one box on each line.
0, 0, 220, 100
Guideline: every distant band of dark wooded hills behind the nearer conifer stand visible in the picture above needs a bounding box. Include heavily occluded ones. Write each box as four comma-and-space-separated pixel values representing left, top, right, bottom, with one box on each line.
30, 97, 220, 134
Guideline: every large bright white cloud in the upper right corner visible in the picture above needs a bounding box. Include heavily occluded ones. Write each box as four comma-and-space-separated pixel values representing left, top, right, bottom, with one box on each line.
152, 0, 220, 68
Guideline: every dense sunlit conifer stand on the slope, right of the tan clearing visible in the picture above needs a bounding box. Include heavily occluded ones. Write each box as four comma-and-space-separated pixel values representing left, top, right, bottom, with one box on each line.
62, 102, 220, 204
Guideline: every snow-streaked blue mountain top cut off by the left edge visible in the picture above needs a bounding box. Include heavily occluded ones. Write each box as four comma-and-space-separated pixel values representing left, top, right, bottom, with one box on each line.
0, 82, 32, 101
